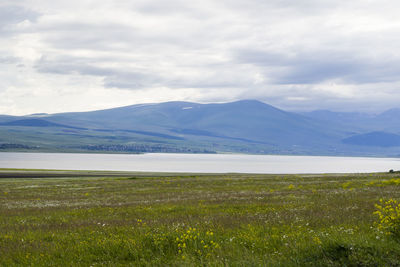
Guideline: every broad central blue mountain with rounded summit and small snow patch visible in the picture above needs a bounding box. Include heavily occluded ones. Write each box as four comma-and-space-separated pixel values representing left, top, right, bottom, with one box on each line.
43, 100, 346, 145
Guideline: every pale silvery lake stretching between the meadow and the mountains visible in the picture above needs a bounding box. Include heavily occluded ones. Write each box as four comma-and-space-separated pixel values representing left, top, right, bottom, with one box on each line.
0, 152, 400, 173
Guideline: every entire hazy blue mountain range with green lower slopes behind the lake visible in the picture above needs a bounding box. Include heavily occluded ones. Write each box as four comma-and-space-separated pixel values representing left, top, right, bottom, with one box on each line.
0, 100, 400, 156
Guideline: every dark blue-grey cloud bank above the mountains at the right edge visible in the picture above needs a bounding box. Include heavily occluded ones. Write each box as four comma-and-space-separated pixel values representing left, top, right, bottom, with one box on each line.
233, 49, 400, 84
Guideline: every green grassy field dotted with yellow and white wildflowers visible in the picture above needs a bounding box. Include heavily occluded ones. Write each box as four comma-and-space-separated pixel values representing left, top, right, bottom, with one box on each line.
0, 170, 400, 266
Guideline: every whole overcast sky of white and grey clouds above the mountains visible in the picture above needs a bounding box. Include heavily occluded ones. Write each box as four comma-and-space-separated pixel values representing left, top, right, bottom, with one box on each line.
0, 0, 400, 115
